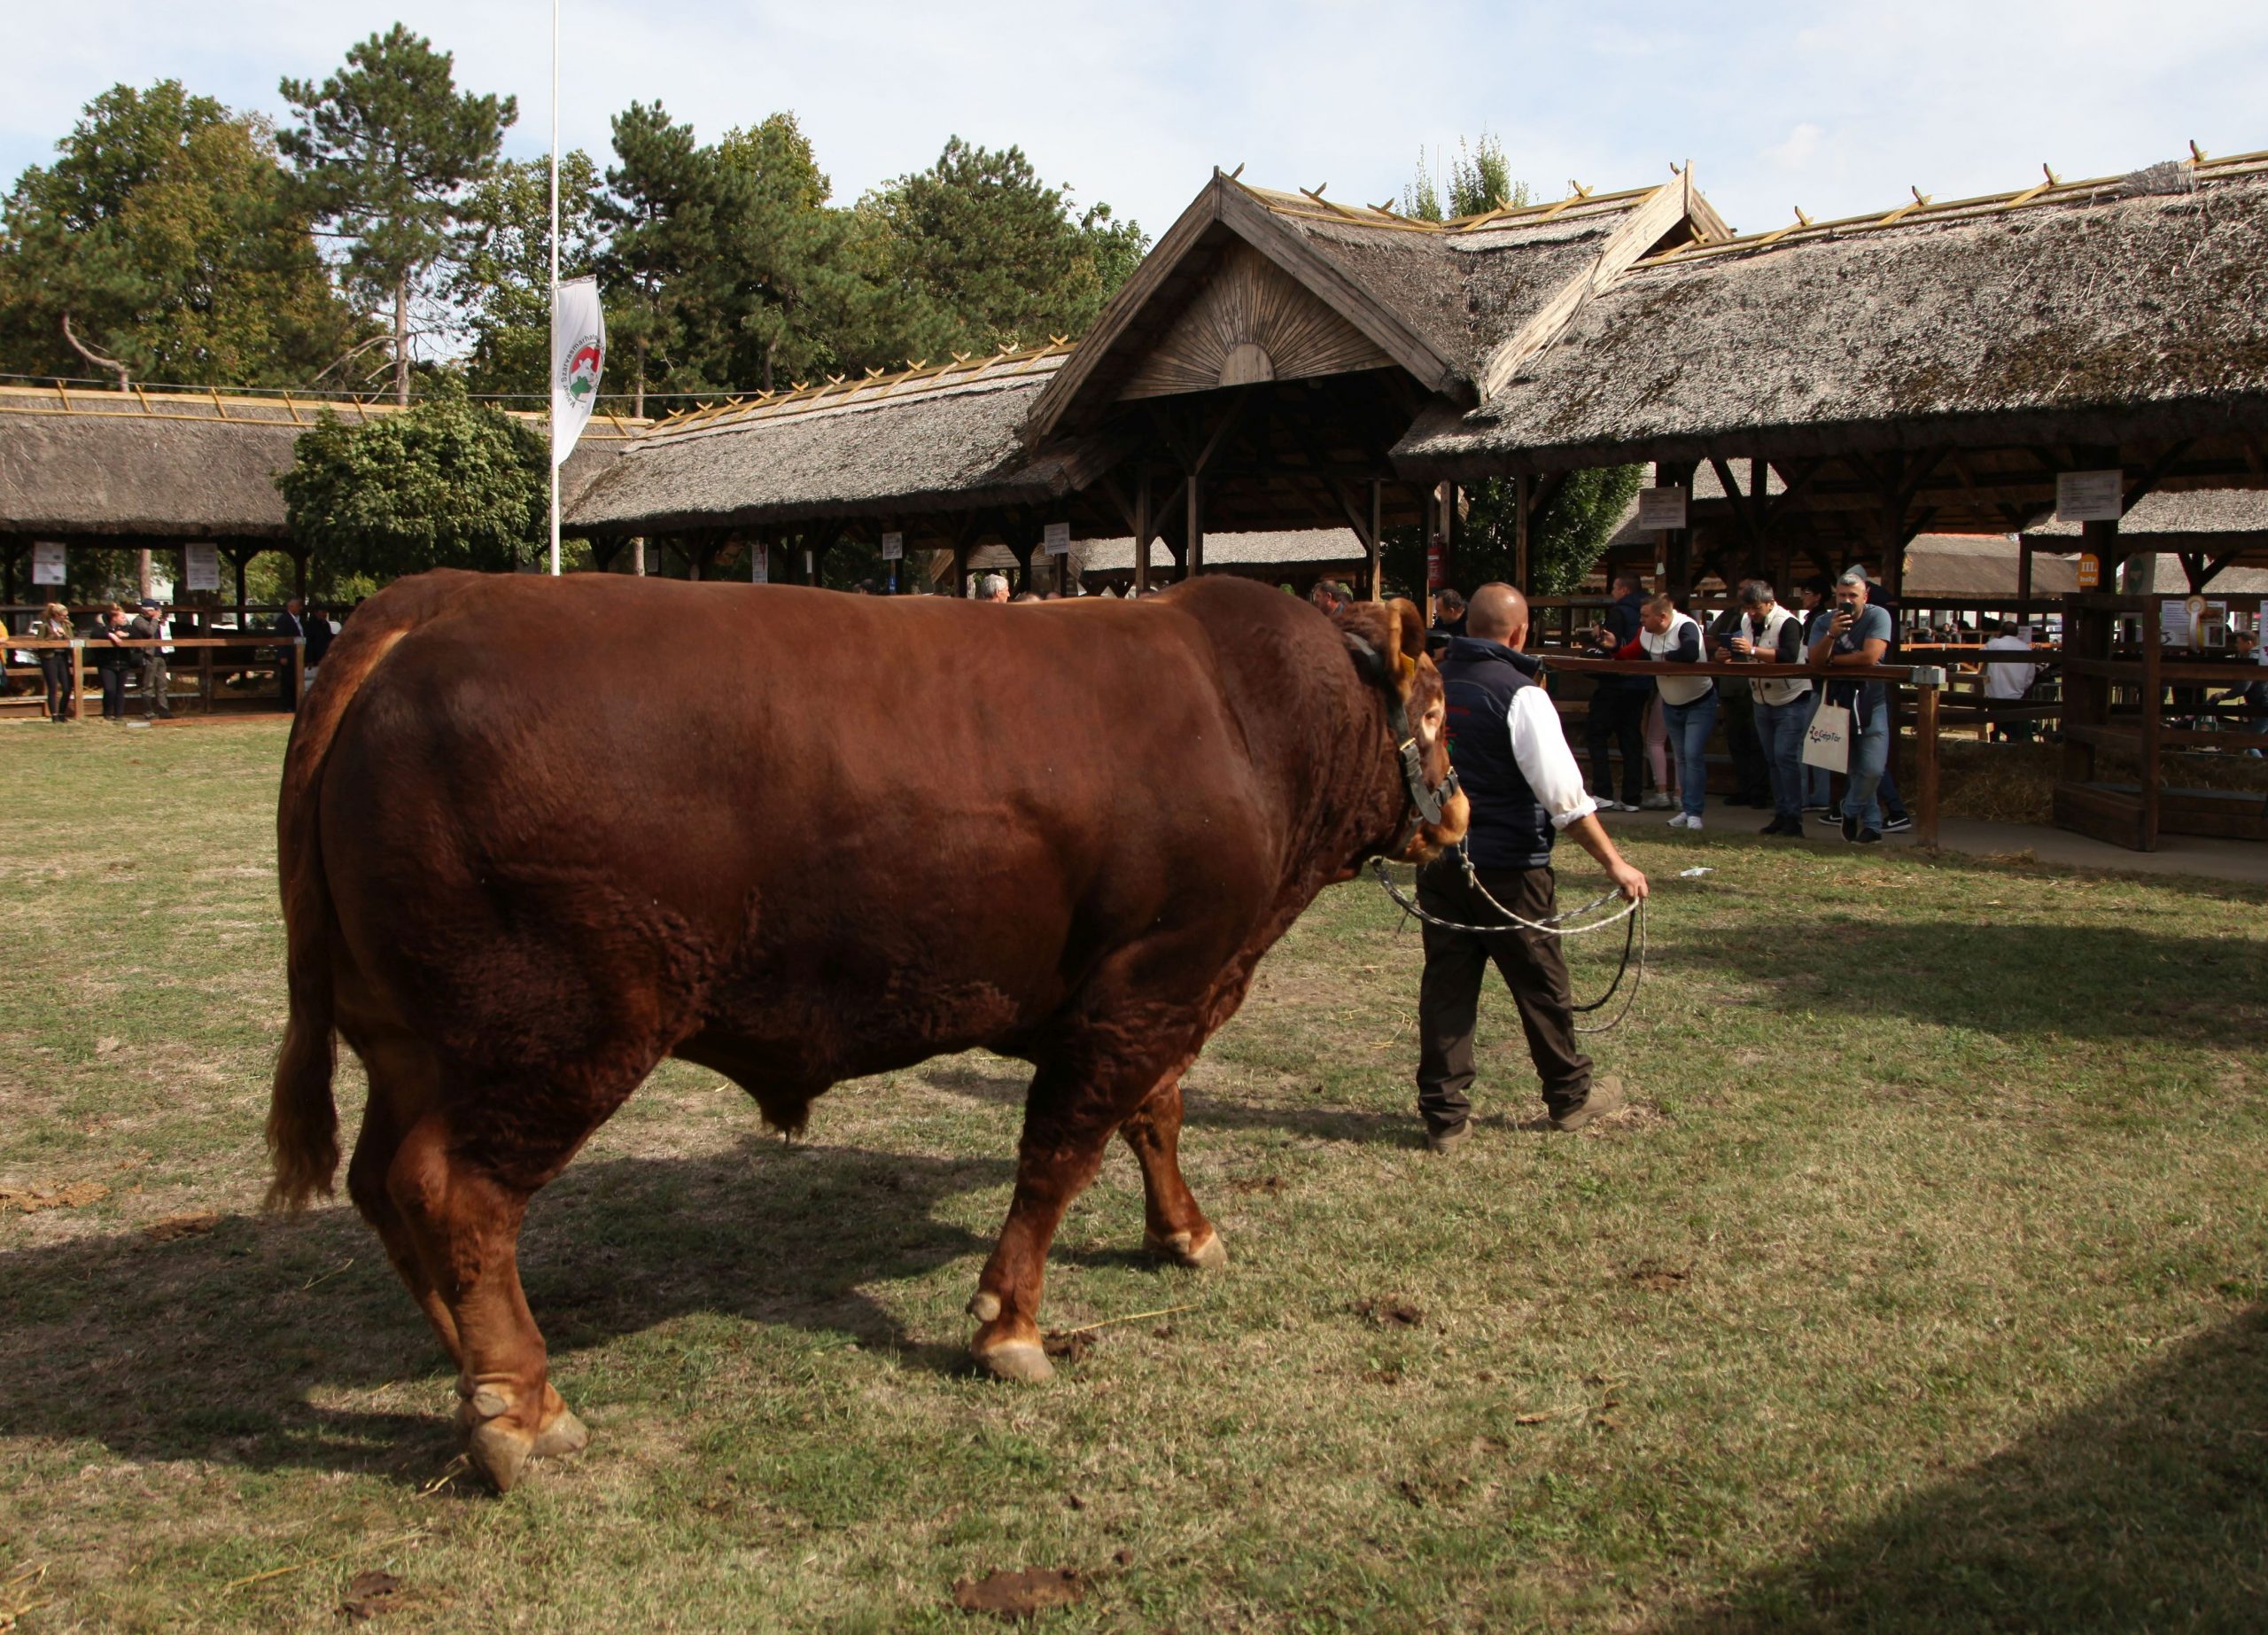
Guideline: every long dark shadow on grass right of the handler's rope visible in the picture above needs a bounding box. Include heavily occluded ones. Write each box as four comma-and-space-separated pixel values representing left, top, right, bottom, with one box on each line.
1649, 915, 2268, 1050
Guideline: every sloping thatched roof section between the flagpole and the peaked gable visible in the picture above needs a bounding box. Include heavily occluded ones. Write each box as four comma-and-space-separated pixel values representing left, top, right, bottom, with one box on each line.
571, 349, 1077, 533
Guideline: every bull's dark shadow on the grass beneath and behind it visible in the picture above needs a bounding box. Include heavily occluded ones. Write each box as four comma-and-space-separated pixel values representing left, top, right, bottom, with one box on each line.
0, 1143, 1009, 1478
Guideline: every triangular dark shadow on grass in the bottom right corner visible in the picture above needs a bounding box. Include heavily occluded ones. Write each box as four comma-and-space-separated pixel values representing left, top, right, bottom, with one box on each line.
1656, 1309, 2268, 1635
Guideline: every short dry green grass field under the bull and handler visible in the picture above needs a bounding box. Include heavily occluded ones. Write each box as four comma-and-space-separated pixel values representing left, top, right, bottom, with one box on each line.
0, 723, 2268, 1632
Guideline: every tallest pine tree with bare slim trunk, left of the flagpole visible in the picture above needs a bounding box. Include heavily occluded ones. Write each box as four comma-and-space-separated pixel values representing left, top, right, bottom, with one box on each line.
279, 23, 519, 403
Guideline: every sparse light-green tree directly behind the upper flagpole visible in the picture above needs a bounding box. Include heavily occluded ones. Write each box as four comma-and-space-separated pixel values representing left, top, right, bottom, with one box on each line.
447, 150, 603, 401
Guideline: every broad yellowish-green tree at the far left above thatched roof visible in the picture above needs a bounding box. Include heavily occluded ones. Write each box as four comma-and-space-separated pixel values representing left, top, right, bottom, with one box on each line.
0, 80, 358, 385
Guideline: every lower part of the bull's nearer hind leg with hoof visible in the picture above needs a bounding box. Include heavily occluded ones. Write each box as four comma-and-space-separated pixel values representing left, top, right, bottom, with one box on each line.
385, 1113, 590, 1492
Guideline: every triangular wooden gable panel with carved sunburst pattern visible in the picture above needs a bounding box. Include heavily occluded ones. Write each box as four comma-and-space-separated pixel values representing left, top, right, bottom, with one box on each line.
1122, 243, 1393, 397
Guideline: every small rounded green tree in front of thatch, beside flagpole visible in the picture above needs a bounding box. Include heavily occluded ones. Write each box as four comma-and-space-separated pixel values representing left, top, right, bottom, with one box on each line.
276, 374, 551, 585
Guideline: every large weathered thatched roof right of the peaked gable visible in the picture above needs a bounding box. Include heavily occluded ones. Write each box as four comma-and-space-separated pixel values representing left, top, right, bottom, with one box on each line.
1394, 166, 2268, 476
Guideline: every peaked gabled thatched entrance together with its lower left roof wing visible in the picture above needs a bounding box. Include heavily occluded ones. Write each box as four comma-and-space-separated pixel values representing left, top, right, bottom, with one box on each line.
571, 172, 1728, 572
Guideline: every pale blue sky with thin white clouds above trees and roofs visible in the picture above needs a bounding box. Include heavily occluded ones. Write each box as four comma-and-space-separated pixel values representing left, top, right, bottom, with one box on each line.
0, 0, 2268, 236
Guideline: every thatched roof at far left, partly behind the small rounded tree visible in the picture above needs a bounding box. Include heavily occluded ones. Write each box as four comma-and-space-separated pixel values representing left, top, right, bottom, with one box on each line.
0, 388, 641, 542
